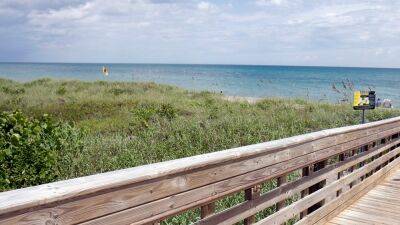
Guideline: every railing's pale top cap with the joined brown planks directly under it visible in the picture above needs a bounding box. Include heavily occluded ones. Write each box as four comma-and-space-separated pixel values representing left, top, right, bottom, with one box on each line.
0, 117, 400, 224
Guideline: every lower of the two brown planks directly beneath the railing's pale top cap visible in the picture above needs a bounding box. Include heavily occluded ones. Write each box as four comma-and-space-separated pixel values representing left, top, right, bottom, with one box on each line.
79, 134, 400, 224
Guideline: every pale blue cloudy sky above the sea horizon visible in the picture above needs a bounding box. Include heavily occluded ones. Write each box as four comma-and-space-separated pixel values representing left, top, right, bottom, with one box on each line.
0, 0, 400, 67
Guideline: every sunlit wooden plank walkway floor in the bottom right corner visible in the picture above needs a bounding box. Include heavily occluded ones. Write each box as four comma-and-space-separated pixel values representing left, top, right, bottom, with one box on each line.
327, 168, 400, 225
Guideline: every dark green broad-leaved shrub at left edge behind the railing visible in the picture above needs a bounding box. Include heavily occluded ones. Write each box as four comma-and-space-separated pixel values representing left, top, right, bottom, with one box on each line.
0, 111, 82, 191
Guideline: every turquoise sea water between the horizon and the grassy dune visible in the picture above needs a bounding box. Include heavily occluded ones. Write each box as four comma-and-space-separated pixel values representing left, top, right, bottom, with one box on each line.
0, 63, 400, 107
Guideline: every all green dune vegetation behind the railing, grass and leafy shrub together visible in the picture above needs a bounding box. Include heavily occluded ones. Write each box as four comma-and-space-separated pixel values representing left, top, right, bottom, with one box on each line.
0, 79, 400, 224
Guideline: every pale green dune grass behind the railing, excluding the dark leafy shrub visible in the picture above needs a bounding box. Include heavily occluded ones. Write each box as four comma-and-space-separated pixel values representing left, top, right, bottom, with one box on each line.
0, 79, 400, 224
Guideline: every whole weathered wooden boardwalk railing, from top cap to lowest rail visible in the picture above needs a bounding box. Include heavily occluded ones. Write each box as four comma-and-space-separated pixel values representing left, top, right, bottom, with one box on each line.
0, 117, 400, 225
